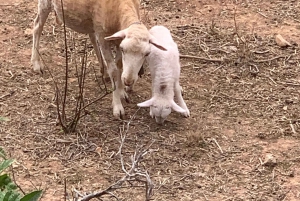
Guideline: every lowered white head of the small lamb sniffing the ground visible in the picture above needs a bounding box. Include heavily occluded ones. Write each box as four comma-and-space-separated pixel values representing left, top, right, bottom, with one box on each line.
137, 97, 186, 124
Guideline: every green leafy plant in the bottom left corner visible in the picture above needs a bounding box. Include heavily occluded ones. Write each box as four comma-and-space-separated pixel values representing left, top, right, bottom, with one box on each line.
0, 147, 42, 201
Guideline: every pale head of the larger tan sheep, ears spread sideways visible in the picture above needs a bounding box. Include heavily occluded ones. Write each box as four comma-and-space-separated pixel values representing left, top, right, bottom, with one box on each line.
105, 24, 166, 86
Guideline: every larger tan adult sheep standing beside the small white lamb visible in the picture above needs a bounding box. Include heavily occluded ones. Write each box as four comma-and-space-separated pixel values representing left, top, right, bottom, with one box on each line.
31, 0, 166, 118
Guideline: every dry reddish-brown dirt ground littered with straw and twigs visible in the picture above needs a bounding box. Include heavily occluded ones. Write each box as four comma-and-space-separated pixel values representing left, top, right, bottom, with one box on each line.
0, 0, 300, 201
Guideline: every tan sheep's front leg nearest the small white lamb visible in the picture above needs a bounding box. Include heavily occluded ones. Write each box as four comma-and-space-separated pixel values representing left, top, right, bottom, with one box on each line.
97, 35, 128, 119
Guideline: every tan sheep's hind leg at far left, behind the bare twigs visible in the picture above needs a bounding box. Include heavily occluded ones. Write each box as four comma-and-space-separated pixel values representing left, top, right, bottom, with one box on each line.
31, 0, 51, 73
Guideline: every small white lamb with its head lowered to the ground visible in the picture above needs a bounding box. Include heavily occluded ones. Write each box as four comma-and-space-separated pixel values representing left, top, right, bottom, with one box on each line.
137, 26, 190, 124
